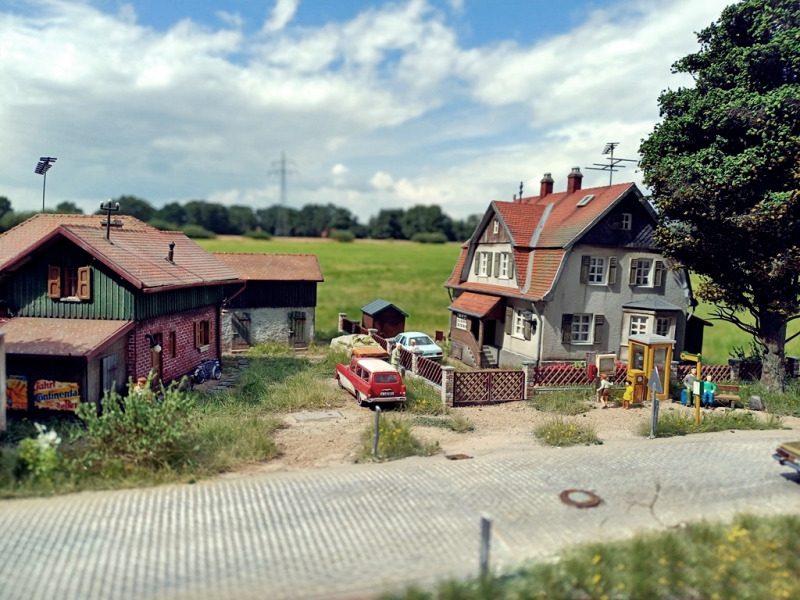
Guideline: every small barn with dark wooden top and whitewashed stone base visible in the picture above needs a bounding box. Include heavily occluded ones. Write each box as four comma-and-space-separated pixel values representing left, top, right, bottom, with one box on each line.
214, 252, 324, 350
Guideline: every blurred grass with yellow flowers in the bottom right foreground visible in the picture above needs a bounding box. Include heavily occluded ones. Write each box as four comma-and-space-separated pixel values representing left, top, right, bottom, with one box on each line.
383, 515, 800, 600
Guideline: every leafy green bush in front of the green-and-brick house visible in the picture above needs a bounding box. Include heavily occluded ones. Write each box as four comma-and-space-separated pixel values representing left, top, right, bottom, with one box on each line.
77, 381, 193, 467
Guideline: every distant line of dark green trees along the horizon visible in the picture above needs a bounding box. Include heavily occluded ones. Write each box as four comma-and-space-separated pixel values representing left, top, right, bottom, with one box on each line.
0, 196, 480, 242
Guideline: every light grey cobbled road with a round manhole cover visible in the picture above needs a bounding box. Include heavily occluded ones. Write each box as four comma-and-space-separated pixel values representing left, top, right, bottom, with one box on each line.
0, 431, 800, 600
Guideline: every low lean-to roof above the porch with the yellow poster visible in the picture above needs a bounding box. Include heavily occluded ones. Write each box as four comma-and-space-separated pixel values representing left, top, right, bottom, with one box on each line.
0, 317, 135, 359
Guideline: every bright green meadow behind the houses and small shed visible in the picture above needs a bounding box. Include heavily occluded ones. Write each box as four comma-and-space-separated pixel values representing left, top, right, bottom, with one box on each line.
198, 236, 800, 364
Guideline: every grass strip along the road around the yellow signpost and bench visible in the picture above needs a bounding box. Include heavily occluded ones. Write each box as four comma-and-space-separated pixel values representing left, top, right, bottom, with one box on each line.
639, 408, 783, 437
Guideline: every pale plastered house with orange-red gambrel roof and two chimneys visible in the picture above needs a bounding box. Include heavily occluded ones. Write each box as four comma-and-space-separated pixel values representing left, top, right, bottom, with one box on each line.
445, 167, 702, 367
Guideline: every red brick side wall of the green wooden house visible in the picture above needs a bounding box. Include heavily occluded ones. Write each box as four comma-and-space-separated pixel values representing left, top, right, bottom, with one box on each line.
127, 306, 220, 383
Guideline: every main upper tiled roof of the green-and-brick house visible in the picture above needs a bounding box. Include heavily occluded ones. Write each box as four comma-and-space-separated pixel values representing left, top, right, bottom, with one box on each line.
0, 215, 241, 292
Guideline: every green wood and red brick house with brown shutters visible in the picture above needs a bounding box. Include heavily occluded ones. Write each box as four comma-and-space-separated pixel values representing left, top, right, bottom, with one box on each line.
0, 214, 244, 410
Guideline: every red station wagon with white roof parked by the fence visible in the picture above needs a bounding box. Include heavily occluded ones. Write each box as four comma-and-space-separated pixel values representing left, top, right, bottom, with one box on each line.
336, 356, 406, 406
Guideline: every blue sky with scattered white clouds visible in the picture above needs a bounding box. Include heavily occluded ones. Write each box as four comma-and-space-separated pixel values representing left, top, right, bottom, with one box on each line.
0, 0, 732, 224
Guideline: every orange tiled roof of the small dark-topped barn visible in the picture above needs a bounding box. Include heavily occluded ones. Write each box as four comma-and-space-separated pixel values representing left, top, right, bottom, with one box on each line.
214, 252, 325, 281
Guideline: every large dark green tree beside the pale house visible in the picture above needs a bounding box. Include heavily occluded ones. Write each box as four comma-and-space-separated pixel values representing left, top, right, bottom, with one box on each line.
640, 0, 800, 391
